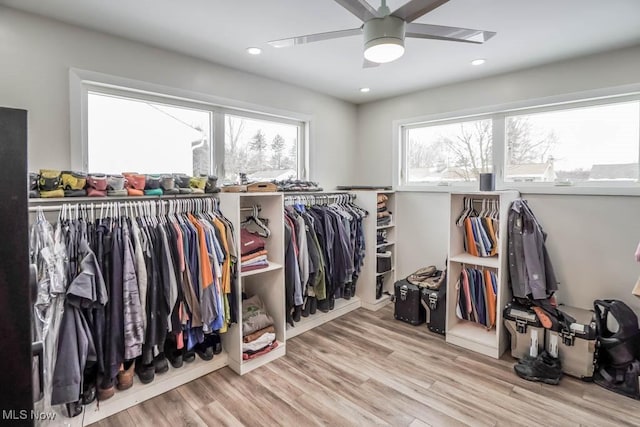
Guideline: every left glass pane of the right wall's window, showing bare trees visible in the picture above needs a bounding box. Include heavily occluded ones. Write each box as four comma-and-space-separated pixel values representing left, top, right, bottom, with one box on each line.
406, 120, 493, 183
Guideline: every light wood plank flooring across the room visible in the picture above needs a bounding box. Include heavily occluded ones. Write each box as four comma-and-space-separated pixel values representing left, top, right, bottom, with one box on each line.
93, 306, 640, 427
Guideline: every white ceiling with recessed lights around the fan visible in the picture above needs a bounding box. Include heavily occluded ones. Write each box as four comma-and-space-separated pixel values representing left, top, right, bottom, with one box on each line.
0, 0, 640, 103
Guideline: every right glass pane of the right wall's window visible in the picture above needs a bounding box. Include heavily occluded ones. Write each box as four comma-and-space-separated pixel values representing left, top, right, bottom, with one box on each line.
505, 102, 640, 182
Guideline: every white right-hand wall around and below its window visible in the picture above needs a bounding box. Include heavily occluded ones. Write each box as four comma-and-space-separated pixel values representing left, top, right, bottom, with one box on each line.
356, 46, 640, 313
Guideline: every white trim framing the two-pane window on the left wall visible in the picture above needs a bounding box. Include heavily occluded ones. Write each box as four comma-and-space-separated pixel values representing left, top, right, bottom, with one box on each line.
69, 68, 313, 180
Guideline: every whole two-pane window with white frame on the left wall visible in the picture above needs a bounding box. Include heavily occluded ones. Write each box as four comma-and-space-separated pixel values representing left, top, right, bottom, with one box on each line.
77, 70, 308, 184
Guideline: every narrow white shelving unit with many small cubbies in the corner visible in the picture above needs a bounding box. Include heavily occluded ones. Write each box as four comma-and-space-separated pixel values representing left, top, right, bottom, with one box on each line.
354, 190, 397, 310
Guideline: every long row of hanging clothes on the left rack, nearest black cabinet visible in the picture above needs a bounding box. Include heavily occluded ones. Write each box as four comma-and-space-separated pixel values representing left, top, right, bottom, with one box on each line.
31, 200, 238, 418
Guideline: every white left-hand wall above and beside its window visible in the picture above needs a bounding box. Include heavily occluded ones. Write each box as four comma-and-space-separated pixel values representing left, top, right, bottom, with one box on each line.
0, 7, 356, 188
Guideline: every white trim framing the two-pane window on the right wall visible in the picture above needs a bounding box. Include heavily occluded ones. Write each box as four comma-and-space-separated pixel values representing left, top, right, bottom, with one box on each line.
392, 84, 640, 196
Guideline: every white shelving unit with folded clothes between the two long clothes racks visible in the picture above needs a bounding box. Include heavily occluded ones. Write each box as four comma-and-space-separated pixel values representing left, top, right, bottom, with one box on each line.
219, 193, 286, 375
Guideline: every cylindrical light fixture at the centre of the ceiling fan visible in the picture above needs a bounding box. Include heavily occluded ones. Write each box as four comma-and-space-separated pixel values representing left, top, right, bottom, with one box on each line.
364, 16, 405, 64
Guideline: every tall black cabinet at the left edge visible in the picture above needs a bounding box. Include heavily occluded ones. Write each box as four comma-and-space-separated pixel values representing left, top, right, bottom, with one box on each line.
0, 108, 33, 425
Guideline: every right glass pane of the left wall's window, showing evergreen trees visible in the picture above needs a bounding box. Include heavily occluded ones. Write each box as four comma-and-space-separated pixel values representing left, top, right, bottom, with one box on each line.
224, 114, 301, 181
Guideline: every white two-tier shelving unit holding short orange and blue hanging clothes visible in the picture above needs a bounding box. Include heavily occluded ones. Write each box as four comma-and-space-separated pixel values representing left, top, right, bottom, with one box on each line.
446, 191, 520, 359
